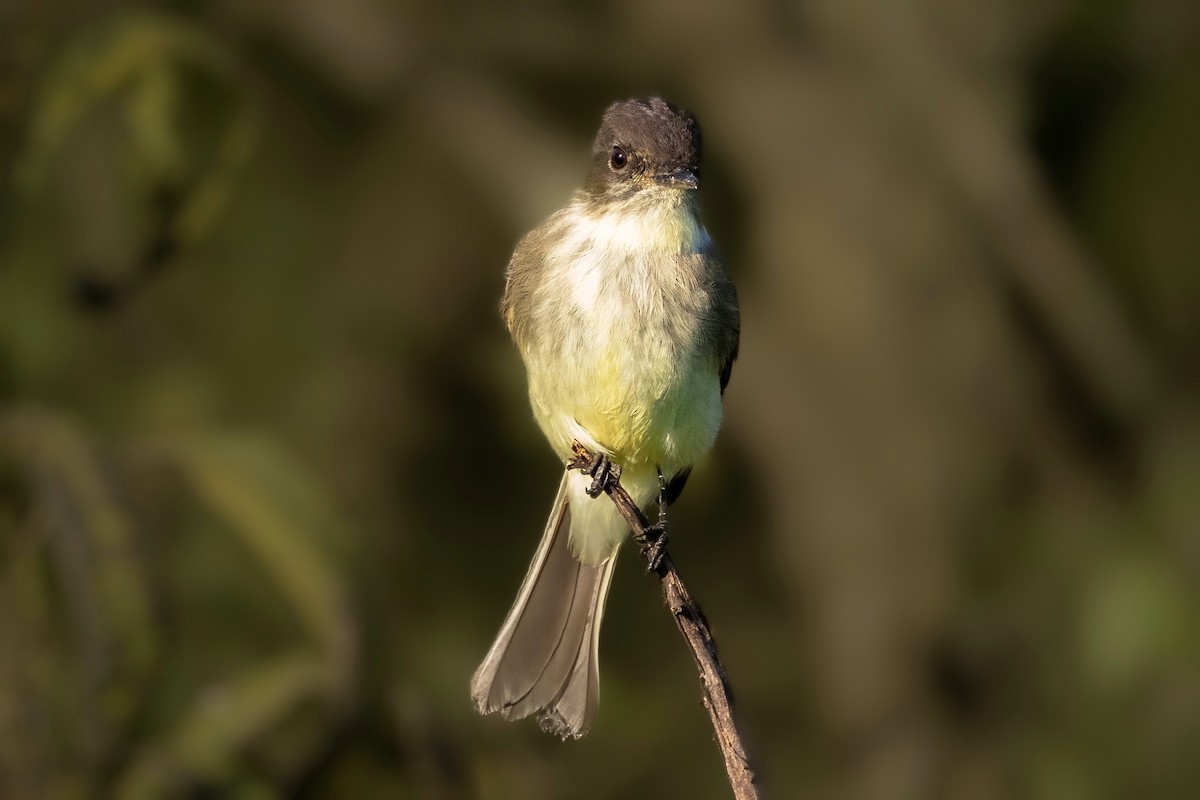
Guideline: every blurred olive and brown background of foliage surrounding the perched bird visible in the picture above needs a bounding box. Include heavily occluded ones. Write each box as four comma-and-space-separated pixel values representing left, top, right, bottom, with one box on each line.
0, 0, 1200, 800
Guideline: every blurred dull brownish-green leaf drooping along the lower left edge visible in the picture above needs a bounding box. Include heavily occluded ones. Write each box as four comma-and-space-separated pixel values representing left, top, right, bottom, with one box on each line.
0, 411, 160, 777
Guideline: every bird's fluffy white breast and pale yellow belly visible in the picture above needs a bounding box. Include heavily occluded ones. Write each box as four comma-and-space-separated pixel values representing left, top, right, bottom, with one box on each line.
526, 196, 720, 471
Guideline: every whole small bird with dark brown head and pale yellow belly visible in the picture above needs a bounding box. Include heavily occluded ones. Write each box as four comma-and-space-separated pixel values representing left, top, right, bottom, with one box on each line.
470, 97, 739, 739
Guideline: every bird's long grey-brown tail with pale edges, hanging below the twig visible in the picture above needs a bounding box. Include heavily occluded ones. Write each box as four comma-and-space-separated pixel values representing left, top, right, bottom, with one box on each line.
470, 473, 617, 739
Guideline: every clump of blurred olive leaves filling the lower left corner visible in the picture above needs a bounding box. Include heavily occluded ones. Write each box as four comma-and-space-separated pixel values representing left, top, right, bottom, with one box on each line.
0, 410, 354, 798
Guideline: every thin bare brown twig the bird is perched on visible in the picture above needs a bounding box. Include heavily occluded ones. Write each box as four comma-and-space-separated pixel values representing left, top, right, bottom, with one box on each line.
566, 443, 758, 800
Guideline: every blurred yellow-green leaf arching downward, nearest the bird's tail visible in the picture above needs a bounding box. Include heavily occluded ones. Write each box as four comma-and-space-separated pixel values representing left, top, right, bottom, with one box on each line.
167, 435, 353, 685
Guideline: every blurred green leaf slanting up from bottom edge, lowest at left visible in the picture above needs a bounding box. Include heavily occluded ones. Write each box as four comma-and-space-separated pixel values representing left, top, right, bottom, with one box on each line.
116, 651, 329, 800
